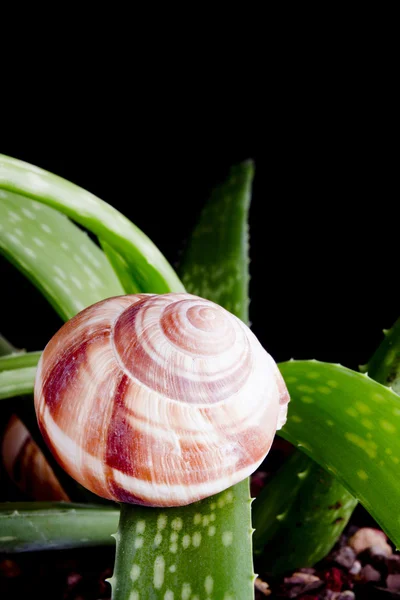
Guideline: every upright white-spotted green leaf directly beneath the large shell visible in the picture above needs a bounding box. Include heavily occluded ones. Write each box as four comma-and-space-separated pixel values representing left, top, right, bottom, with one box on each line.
111, 485, 254, 600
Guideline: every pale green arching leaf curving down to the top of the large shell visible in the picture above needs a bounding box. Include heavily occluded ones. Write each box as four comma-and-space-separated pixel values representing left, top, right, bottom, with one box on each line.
0, 155, 184, 294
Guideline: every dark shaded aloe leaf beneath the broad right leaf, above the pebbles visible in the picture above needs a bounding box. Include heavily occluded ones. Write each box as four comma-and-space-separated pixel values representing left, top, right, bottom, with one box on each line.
253, 451, 357, 575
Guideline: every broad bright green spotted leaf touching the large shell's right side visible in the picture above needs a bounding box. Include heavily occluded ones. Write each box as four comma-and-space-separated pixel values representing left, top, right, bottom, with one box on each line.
279, 361, 400, 546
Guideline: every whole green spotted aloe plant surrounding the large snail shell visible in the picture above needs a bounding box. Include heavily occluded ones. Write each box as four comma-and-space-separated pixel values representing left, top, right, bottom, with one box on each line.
0, 157, 400, 600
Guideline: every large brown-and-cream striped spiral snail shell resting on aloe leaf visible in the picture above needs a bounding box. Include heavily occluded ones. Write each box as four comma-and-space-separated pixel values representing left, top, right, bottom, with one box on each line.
34, 293, 289, 506
